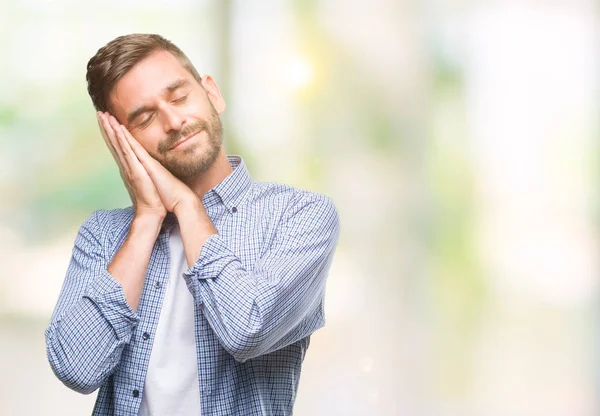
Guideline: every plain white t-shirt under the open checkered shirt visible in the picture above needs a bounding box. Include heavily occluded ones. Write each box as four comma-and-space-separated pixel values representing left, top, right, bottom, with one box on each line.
138, 225, 200, 416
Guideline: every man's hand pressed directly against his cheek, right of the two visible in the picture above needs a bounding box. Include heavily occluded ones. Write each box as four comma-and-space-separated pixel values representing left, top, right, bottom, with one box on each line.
115, 120, 202, 214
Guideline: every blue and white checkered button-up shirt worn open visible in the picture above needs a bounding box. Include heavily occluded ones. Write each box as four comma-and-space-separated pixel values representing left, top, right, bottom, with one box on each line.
46, 156, 339, 416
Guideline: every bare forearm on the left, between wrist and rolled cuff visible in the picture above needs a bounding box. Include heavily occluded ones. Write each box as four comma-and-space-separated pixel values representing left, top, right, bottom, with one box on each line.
107, 215, 163, 311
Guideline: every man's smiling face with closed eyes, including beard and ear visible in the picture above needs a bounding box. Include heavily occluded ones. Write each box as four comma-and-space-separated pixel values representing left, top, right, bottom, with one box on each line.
109, 51, 225, 180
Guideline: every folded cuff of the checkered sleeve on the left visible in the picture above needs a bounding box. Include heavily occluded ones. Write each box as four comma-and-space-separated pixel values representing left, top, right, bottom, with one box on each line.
83, 270, 139, 339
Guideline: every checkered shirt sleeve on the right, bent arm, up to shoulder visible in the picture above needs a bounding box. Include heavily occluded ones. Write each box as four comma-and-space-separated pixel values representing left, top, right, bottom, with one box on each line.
184, 193, 339, 362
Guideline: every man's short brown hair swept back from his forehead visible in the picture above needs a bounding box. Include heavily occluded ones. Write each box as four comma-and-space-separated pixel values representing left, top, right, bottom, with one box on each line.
85, 33, 201, 111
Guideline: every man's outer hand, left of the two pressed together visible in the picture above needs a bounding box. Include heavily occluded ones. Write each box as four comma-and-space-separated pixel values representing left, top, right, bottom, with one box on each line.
97, 112, 167, 219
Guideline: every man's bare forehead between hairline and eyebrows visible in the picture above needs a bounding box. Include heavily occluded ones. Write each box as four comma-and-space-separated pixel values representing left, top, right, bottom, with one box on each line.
109, 51, 194, 113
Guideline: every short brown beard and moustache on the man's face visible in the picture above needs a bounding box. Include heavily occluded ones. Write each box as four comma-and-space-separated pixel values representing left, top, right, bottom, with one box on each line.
155, 108, 223, 181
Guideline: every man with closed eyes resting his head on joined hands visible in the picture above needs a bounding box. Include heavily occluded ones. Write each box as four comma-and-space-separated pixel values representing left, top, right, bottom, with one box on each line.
46, 34, 339, 416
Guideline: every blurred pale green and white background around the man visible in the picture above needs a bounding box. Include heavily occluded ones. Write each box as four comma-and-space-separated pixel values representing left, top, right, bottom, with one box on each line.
0, 0, 600, 416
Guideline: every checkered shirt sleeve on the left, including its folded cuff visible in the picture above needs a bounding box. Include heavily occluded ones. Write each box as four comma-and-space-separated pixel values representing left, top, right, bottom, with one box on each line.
45, 211, 139, 394
